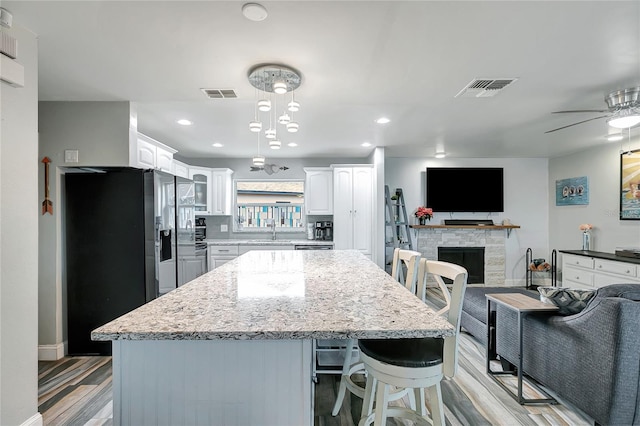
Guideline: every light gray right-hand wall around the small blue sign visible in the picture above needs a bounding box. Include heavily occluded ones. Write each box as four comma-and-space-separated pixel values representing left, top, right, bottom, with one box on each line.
548, 137, 640, 253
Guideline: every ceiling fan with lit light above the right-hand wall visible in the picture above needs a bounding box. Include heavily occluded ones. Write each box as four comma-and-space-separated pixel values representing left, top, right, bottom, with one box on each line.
545, 87, 640, 133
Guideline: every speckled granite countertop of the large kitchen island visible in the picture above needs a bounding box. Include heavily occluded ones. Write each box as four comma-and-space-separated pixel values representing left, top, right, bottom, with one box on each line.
91, 250, 454, 340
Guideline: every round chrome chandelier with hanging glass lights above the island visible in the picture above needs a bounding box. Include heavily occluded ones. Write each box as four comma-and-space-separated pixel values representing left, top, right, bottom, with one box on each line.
248, 64, 302, 149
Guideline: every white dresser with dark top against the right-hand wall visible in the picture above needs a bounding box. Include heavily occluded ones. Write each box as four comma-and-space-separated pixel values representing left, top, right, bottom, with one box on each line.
560, 250, 640, 289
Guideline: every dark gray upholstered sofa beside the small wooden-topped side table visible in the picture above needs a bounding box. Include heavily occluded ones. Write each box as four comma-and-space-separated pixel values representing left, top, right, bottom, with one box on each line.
462, 284, 640, 425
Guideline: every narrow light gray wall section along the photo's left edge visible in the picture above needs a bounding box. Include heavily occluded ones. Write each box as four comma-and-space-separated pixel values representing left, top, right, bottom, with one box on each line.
0, 22, 42, 425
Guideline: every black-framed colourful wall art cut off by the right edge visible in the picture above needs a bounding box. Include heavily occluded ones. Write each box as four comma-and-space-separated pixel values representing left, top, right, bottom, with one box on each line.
620, 149, 640, 220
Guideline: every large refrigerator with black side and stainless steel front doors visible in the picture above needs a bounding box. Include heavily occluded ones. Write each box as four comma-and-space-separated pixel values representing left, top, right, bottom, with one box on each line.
64, 168, 195, 355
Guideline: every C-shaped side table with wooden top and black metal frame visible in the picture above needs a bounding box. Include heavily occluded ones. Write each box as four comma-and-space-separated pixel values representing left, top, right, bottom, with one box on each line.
486, 293, 558, 405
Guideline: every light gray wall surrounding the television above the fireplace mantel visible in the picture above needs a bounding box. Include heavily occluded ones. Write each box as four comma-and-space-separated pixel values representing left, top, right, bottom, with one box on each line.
385, 158, 550, 286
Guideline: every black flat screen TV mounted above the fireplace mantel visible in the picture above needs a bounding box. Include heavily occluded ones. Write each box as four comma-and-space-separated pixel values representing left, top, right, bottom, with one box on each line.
426, 167, 504, 213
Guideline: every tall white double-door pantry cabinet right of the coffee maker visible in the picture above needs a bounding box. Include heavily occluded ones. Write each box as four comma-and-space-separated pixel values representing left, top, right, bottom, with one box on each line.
333, 165, 373, 258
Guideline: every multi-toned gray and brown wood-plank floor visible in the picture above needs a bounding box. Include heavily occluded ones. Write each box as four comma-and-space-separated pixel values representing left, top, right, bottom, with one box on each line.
38, 333, 593, 426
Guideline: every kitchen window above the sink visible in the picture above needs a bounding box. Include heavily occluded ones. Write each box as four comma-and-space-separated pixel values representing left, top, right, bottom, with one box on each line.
234, 179, 304, 231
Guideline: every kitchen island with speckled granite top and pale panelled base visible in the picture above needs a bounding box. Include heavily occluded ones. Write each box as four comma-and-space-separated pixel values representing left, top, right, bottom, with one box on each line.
91, 250, 454, 426
